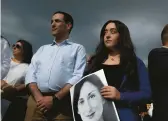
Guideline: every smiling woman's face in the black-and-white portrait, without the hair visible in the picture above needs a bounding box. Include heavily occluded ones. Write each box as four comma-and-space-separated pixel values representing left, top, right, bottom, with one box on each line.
78, 82, 104, 121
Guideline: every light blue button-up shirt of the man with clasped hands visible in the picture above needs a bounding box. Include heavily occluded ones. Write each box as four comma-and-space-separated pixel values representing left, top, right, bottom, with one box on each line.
25, 40, 86, 92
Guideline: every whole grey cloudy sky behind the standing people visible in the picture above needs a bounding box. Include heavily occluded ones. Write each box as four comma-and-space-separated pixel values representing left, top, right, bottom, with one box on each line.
1, 0, 168, 63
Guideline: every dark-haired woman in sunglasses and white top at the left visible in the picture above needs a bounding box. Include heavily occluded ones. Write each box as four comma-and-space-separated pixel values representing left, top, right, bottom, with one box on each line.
1, 40, 33, 121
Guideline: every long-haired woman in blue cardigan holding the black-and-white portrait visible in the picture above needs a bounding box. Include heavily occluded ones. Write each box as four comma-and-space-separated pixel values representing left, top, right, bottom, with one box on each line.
85, 20, 151, 121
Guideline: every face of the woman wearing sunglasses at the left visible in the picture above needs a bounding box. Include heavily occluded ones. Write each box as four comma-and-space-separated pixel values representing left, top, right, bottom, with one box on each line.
12, 42, 23, 56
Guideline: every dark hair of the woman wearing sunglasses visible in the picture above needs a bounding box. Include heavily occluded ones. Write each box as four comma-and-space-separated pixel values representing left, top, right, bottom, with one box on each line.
17, 39, 33, 64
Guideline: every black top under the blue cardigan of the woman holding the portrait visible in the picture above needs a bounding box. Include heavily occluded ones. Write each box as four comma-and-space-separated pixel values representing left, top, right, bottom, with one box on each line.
98, 64, 124, 89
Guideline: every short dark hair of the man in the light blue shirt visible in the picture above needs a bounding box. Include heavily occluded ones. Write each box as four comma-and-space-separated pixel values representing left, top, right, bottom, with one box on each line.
53, 11, 74, 33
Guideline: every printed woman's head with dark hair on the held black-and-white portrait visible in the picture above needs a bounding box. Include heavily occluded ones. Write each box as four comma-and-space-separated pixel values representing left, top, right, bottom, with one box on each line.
73, 75, 105, 121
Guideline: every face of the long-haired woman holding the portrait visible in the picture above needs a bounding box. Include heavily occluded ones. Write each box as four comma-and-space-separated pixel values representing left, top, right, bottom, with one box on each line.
104, 23, 119, 49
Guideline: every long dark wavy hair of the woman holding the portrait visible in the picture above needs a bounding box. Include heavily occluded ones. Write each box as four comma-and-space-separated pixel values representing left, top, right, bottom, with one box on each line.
85, 20, 139, 90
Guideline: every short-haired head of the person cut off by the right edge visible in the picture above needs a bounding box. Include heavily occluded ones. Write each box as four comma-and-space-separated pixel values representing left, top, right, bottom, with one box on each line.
161, 24, 168, 45
